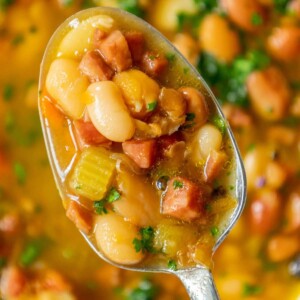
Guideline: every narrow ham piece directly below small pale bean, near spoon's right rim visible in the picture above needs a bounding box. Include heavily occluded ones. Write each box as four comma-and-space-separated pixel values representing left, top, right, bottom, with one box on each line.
204, 150, 227, 182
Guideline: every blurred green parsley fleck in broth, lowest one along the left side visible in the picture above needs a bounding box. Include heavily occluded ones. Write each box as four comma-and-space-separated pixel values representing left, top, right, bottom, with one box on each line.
20, 237, 49, 267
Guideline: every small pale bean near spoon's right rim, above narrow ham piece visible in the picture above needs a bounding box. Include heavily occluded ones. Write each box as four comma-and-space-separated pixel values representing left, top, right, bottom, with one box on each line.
197, 124, 222, 159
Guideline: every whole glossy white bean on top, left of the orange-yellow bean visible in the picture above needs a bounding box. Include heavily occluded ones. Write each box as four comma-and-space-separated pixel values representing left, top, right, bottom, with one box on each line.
86, 81, 135, 142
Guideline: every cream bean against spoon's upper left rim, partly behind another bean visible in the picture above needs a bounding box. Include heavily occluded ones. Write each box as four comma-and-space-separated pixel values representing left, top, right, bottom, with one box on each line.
46, 58, 89, 119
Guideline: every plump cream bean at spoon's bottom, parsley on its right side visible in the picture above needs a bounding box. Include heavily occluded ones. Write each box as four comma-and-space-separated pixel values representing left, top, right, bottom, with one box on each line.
95, 213, 144, 265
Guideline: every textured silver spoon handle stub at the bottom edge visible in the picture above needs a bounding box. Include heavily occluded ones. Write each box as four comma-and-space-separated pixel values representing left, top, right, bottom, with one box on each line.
175, 268, 219, 300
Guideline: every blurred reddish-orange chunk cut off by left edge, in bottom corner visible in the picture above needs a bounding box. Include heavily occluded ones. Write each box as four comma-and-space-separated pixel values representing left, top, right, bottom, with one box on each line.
0, 266, 27, 299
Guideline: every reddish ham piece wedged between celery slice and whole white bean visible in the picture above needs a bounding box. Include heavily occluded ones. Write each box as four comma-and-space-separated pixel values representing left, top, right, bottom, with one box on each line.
73, 120, 111, 148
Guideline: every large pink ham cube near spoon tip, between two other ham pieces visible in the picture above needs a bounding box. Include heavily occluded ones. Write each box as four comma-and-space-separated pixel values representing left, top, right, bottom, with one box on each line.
94, 30, 132, 72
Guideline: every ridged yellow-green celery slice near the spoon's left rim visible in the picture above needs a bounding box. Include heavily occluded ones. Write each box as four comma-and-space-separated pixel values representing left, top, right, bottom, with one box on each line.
69, 147, 116, 200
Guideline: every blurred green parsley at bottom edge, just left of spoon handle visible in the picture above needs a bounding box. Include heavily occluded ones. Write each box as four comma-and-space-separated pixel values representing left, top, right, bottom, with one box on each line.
126, 279, 158, 300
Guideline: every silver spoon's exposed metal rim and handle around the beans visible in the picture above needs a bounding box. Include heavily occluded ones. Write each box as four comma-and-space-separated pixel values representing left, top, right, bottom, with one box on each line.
39, 7, 246, 300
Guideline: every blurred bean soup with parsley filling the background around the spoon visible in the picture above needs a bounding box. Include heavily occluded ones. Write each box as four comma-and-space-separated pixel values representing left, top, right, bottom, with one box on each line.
0, 0, 300, 300
